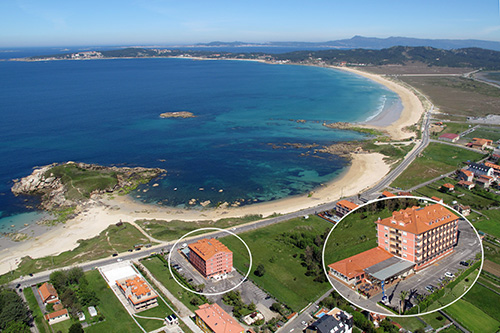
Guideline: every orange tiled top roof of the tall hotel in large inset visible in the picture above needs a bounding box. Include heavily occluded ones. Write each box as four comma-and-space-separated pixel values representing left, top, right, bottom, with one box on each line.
375, 204, 458, 235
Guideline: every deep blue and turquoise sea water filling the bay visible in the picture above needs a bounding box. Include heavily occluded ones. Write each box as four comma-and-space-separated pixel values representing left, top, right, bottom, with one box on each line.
0, 53, 398, 232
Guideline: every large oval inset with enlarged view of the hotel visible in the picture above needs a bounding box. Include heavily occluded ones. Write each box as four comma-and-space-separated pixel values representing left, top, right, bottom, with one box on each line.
323, 196, 483, 316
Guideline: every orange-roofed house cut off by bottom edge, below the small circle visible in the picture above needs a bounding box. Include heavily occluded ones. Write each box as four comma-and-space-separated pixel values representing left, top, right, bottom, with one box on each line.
194, 303, 245, 333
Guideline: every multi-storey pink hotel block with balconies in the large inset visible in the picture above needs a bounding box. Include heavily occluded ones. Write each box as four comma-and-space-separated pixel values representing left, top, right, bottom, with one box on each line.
375, 204, 459, 269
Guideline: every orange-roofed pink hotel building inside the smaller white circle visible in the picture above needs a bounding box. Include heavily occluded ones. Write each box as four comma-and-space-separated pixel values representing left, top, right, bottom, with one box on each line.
188, 238, 233, 278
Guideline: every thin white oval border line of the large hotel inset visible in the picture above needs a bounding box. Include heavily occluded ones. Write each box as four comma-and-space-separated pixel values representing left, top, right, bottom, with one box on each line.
322, 195, 484, 318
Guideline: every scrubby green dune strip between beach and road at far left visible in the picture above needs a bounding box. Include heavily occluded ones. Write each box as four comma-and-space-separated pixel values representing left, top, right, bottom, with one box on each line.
0, 223, 149, 283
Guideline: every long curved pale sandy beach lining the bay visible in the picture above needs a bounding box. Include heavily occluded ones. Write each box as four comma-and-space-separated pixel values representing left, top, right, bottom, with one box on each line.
0, 68, 424, 274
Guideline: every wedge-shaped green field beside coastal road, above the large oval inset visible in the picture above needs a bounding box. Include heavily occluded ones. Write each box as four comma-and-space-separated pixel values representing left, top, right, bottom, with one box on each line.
391, 142, 483, 189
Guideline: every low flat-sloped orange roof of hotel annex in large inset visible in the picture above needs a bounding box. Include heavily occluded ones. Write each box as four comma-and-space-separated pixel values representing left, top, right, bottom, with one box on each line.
328, 247, 392, 279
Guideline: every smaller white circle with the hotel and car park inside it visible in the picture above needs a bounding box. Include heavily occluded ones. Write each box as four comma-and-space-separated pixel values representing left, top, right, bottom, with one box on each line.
168, 228, 252, 296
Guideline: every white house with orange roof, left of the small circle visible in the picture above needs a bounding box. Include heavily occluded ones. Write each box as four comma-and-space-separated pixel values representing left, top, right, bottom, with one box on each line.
116, 275, 158, 311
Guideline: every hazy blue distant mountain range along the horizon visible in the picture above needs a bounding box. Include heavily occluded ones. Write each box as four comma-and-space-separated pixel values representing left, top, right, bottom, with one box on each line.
193, 36, 500, 51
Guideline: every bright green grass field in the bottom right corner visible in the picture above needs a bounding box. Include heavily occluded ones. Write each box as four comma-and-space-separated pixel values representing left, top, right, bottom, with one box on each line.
444, 299, 500, 332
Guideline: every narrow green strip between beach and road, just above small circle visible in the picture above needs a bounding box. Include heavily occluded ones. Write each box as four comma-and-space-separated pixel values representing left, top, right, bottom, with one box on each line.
136, 215, 262, 241
